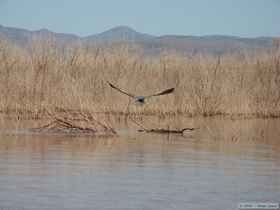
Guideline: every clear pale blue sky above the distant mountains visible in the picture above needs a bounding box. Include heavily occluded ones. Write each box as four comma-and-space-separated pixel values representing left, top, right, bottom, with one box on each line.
0, 0, 280, 37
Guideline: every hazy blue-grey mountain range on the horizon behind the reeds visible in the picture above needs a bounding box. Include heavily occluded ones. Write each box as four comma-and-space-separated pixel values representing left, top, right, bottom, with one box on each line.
0, 25, 274, 54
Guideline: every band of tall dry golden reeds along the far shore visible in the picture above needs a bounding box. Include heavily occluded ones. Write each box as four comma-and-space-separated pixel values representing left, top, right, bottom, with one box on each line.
0, 35, 280, 117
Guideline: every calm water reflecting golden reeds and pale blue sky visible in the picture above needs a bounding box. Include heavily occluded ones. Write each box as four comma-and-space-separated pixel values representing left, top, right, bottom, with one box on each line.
0, 119, 280, 210
